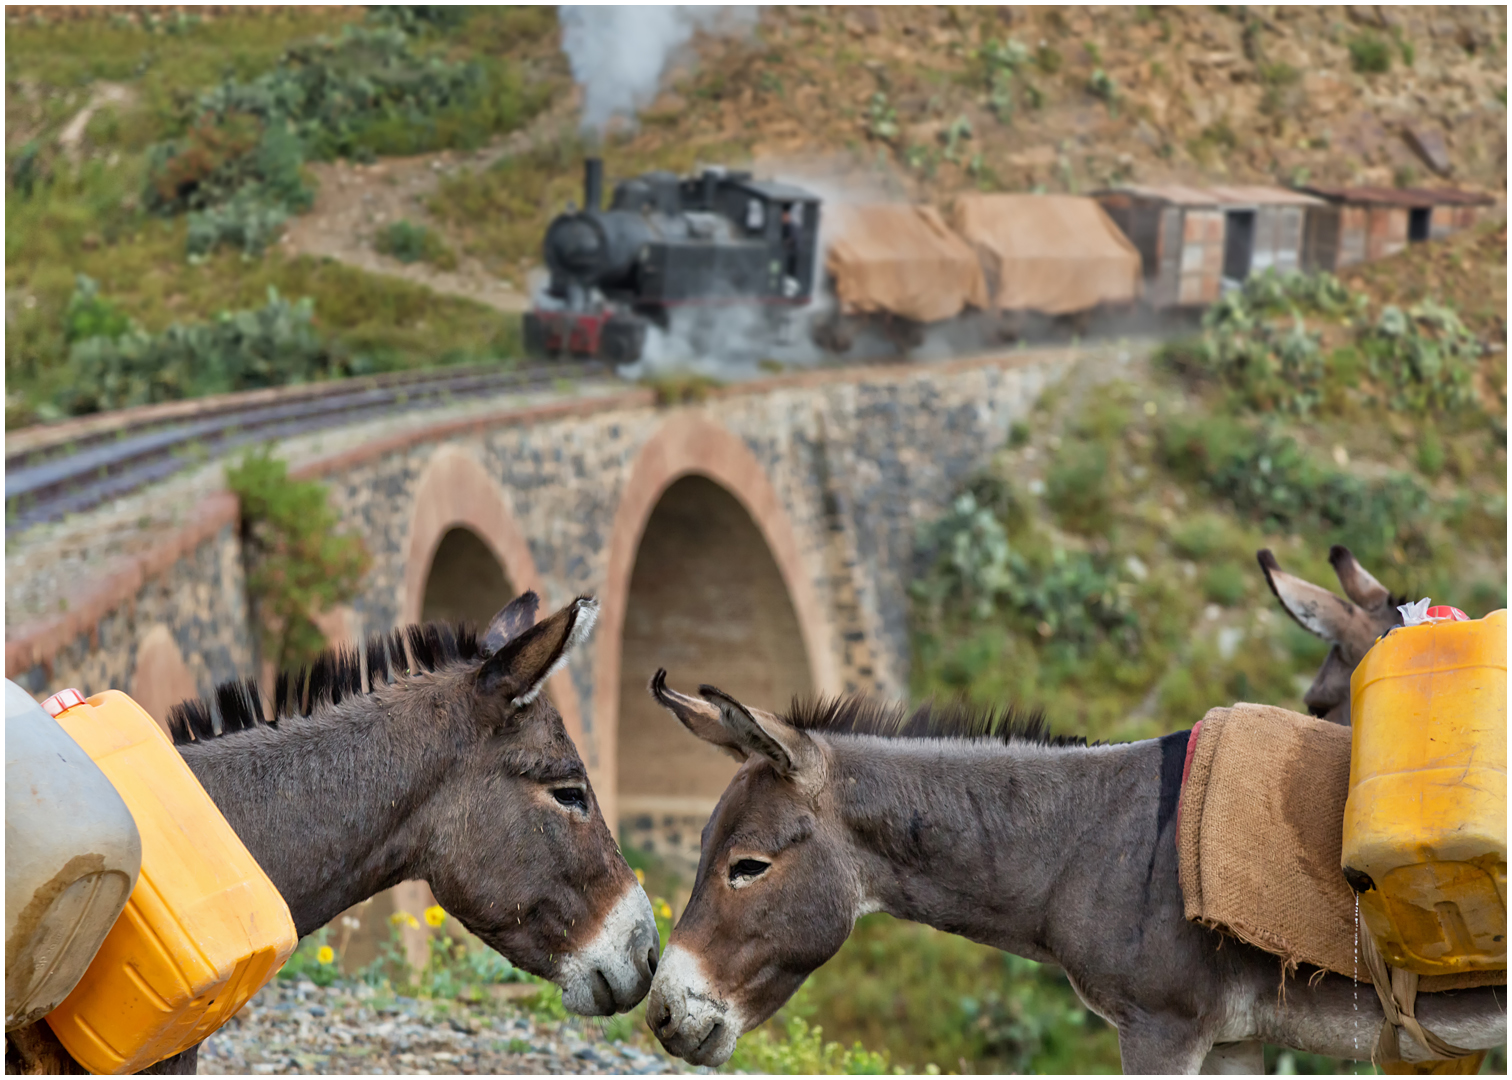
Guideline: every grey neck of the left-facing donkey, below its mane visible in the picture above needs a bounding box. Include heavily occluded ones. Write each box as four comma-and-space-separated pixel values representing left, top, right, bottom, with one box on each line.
827, 737, 1161, 961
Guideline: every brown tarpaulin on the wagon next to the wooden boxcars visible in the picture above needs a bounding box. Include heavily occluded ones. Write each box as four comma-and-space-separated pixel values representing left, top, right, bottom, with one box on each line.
956, 195, 1143, 315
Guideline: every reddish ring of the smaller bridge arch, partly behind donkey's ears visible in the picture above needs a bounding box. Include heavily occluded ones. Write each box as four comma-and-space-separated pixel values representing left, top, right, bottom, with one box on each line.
402, 446, 588, 756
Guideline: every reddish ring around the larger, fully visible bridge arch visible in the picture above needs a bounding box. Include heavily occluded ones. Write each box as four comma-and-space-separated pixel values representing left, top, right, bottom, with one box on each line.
593, 411, 844, 827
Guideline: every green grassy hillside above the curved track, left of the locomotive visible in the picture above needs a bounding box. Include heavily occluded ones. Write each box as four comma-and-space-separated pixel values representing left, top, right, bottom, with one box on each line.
6, 8, 555, 427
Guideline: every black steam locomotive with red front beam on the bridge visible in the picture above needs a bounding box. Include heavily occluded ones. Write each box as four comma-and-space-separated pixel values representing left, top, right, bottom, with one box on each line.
525, 157, 820, 363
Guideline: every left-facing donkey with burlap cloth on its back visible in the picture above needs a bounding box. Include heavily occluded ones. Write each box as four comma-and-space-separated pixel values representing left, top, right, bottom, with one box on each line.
646, 672, 1506, 1072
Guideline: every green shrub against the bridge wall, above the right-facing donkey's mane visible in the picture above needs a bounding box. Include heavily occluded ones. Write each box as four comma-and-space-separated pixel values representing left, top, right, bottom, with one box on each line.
225, 446, 372, 672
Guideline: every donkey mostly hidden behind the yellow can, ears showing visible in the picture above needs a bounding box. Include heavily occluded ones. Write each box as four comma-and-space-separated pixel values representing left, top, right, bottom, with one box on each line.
1256, 545, 1406, 725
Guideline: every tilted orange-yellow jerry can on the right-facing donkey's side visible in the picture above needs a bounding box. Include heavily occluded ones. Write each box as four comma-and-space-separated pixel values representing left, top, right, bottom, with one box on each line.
47, 690, 298, 1072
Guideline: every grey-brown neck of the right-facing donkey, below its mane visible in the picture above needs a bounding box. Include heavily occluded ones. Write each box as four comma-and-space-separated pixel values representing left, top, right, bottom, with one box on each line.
178, 673, 470, 936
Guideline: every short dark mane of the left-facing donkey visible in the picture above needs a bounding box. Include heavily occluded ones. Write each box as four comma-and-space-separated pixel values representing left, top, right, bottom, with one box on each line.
783, 694, 1087, 746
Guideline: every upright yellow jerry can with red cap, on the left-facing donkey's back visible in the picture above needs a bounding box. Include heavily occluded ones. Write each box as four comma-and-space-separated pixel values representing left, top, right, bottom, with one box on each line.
1343, 608, 1507, 976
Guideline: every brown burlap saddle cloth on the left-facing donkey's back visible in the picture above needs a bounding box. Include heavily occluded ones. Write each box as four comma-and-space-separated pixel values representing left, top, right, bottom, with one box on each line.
1176, 705, 1507, 992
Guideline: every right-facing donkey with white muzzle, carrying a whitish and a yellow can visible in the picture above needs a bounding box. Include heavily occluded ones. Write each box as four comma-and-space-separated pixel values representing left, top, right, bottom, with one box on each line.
8, 593, 659, 1072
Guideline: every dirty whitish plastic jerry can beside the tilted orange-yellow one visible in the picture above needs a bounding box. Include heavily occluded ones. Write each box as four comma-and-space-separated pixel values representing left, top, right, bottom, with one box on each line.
5, 679, 142, 1032
